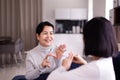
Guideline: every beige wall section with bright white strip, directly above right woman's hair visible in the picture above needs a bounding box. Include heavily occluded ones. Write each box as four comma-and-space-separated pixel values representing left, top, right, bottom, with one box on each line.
93, 0, 113, 19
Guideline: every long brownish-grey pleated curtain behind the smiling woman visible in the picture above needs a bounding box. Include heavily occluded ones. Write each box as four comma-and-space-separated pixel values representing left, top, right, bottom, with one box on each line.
0, 0, 42, 50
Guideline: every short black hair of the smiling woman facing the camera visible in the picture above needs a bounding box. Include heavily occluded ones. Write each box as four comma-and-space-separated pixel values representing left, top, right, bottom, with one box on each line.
36, 21, 54, 34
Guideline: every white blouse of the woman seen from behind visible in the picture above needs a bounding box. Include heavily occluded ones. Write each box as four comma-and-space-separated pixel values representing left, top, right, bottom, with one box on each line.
47, 57, 115, 80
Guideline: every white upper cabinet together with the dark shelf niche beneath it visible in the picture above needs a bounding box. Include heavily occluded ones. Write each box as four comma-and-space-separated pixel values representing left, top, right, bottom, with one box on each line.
55, 8, 87, 34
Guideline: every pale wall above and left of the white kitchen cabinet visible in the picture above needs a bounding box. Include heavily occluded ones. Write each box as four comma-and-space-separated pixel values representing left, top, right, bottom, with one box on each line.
42, 0, 88, 24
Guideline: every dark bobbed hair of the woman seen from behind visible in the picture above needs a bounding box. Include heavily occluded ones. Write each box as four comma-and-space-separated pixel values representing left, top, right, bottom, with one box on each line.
83, 17, 118, 57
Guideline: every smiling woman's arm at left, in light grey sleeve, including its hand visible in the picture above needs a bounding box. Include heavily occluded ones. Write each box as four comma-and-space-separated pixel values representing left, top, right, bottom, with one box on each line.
25, 53, 46, 80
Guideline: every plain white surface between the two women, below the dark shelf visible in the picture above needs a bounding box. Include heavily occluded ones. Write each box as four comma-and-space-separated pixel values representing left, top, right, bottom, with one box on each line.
54, 34, 84, 56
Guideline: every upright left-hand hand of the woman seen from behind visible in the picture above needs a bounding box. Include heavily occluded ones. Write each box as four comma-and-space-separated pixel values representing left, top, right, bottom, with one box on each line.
62, 53, 73, 70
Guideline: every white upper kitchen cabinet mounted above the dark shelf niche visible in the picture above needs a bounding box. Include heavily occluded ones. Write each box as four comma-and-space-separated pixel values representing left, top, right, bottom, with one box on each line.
55, 8, 87, 20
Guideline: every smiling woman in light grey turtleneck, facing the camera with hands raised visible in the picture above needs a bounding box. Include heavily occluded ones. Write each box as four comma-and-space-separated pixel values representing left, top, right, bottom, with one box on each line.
25, 22, 66, 80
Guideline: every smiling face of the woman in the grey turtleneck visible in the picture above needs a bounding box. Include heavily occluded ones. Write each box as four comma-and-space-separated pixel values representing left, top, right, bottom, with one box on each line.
37, 26, 54, 47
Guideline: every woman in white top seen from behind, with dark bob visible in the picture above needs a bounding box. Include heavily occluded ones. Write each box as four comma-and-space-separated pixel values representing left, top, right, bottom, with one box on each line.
47, 17, 118, 80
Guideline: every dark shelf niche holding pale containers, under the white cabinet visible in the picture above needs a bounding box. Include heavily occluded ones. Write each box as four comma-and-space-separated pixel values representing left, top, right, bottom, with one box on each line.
55, 20, 87, 34
